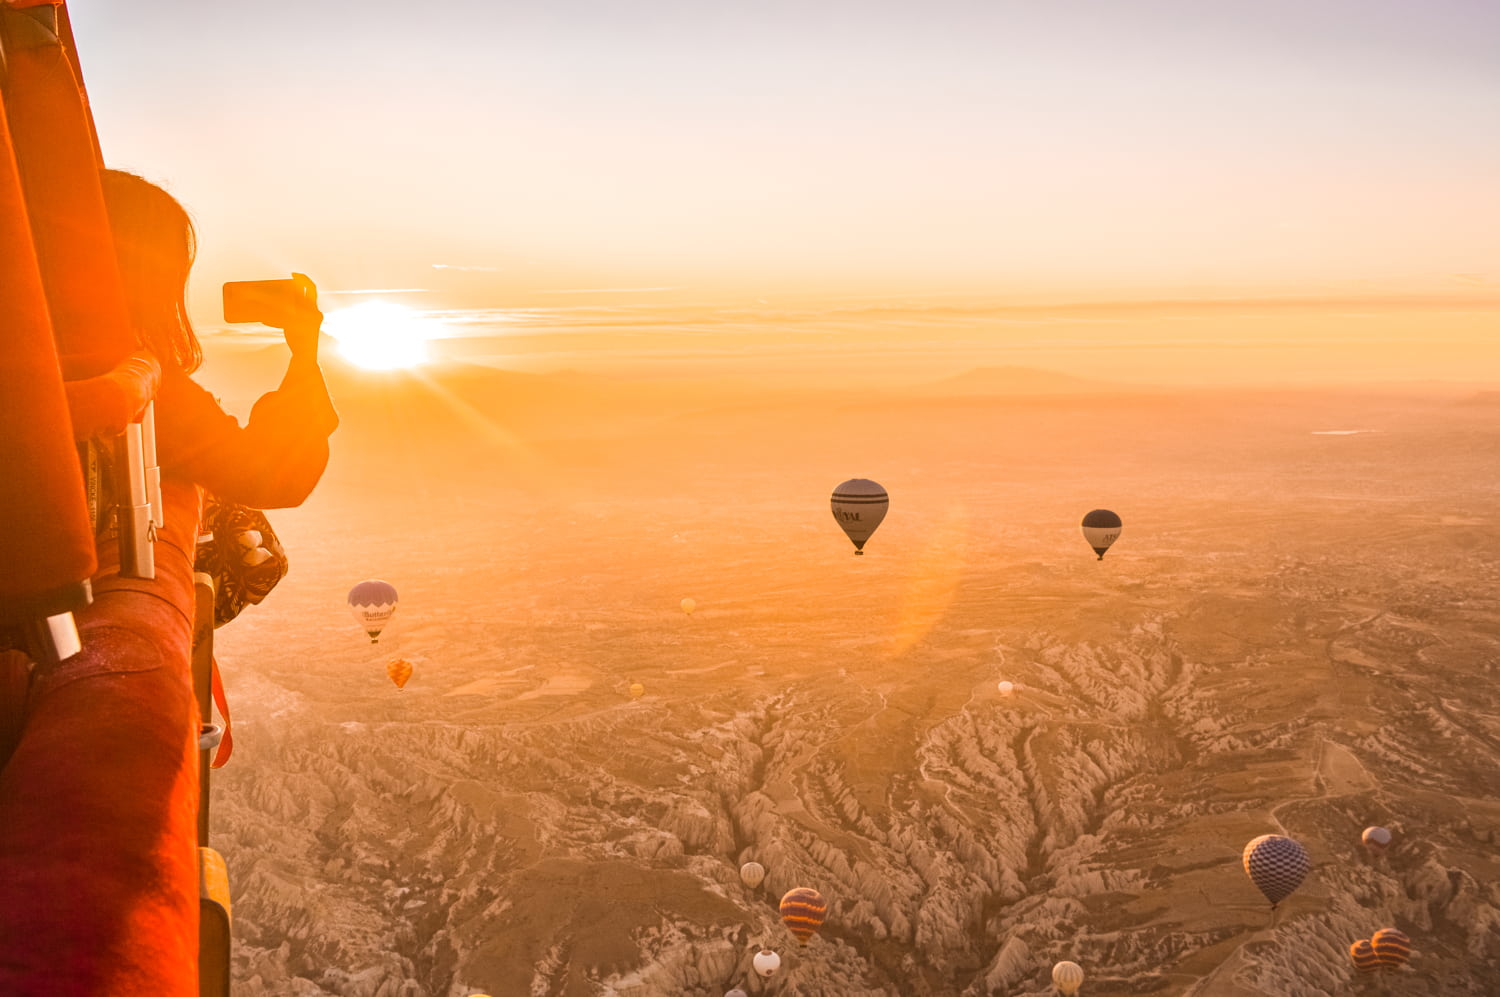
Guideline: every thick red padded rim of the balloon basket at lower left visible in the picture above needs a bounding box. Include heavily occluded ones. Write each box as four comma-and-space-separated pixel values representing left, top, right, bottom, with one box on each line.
0, 481, 198, 997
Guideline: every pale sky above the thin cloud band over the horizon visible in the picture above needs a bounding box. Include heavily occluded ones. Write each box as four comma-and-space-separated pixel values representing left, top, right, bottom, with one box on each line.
69, 0, 1500, 376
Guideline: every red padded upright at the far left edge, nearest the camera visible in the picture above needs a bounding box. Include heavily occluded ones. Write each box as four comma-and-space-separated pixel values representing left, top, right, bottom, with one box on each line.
0, 91, 95, 603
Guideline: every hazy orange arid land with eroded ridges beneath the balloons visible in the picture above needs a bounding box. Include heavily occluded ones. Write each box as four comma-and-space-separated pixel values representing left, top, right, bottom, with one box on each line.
212, 361, 1500, 997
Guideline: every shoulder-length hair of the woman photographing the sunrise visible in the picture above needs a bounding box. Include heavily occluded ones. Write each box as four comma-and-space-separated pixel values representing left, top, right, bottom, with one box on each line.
99, 169, 203, 373
